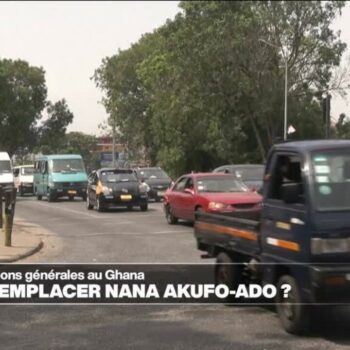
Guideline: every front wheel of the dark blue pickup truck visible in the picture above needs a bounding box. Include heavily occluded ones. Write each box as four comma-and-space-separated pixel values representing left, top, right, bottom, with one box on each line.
276, 275, 311, 334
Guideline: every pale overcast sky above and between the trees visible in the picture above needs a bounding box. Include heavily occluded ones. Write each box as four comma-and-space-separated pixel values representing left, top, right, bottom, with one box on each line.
0, 1, 350, 134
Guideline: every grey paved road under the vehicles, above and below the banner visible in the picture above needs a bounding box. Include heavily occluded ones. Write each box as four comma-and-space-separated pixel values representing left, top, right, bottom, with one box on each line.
0, 198, 350, 350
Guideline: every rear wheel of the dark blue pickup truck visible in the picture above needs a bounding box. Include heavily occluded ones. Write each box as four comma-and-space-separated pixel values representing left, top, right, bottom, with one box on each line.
215, 253, 243, 303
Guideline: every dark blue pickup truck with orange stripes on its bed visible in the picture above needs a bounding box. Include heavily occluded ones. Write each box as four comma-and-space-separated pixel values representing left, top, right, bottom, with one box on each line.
194, 140, 350, 334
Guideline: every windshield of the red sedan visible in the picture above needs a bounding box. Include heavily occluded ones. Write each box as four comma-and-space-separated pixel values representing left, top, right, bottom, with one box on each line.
197, 176, 249, 192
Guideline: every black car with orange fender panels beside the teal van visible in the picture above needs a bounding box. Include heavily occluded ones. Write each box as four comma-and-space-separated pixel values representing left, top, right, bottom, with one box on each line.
86, 168, 148, 212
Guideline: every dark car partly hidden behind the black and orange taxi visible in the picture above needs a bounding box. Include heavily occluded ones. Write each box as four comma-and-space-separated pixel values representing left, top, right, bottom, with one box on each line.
134, 167, 172, 202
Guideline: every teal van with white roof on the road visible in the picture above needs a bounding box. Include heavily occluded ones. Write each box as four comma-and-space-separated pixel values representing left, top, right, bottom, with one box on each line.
34, 154, 87, 202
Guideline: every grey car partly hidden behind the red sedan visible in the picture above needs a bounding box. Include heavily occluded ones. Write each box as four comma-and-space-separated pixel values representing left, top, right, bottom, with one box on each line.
213, 164, 265, 191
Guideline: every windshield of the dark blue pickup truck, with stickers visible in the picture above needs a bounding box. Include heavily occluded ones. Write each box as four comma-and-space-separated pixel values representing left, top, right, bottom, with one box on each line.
312, 150, 350, 211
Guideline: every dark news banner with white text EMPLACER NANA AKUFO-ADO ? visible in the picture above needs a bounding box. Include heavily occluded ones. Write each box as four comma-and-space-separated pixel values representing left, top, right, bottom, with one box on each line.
0, 264, 290, 304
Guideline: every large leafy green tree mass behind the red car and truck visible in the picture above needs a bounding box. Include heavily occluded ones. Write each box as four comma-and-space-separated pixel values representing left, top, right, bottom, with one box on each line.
94, 1, 345, 178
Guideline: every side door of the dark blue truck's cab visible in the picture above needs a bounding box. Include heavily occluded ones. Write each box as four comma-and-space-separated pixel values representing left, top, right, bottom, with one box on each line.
261, 153, 310, 261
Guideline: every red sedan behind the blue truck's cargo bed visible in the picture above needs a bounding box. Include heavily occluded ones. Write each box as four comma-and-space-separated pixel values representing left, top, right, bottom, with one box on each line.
163, 173, 262, 224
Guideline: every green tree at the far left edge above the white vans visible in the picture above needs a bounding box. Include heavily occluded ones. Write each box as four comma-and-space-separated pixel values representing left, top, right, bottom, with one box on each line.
0, 59, 47, 155
